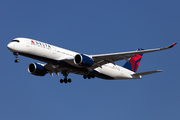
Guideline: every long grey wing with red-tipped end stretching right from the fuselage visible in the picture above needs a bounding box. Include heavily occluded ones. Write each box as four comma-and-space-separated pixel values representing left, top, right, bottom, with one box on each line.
92, 43, 177, 69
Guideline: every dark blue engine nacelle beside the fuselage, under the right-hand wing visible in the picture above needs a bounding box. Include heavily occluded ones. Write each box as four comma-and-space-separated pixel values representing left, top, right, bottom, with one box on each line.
74, 54, 94, 67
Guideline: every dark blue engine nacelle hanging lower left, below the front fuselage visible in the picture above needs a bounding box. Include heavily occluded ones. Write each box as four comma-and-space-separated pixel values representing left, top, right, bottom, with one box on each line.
28, 63, 47, 76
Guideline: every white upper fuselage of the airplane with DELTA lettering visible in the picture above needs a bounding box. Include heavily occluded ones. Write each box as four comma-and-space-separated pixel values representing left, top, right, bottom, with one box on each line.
7, 38, 141, 79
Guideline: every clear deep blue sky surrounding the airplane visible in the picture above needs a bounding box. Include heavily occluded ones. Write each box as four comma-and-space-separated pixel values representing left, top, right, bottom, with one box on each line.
0, 0, 180, 120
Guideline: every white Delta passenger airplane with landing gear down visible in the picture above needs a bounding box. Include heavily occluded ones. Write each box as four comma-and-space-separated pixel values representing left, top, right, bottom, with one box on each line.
7, 37, 177, 83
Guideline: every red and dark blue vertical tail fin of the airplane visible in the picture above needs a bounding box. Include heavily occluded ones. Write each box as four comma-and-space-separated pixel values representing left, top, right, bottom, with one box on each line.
123, 48, 143, 73
